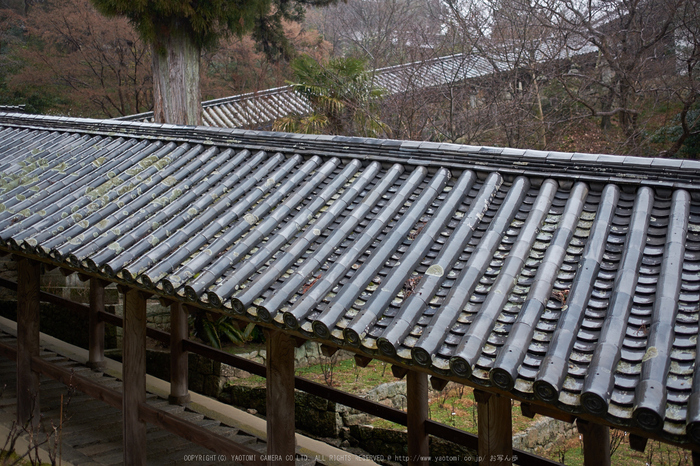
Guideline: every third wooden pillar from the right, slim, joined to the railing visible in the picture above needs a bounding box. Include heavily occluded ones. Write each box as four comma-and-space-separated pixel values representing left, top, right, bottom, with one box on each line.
406, 371, 430, 466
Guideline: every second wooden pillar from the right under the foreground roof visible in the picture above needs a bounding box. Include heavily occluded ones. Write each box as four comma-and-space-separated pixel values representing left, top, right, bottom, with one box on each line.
474, 390, 513, 466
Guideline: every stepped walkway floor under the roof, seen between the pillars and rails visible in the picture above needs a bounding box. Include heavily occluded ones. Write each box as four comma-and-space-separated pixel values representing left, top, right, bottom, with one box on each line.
0, 332, 322, 466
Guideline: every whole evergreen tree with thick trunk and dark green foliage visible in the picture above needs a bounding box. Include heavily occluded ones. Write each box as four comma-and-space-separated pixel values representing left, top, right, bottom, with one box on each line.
91, 0, 335, 125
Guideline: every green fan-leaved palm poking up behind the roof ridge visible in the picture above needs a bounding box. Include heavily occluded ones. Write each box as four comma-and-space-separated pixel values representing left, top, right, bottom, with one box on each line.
275, 55, 388, 137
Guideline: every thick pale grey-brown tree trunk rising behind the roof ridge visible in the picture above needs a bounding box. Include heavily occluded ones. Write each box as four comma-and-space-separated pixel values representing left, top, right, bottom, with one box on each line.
151, 27, 202, 125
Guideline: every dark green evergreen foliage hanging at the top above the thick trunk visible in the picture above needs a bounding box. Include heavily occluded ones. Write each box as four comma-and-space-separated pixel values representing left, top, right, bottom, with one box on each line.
91, 0, 336, 59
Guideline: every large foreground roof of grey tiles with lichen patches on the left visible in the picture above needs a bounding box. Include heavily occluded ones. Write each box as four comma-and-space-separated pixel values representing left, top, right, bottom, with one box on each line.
0, 114, 700, 444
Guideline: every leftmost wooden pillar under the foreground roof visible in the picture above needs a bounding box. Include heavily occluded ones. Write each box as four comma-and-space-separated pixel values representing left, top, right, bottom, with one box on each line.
17, 257, 41, 427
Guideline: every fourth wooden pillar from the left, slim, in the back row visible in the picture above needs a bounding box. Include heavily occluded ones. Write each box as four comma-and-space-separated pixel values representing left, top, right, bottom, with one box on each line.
168, 302, 190, 405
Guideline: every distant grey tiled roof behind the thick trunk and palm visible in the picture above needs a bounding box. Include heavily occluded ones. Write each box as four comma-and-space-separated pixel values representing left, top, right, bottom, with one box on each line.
118, 54, 493, 128
